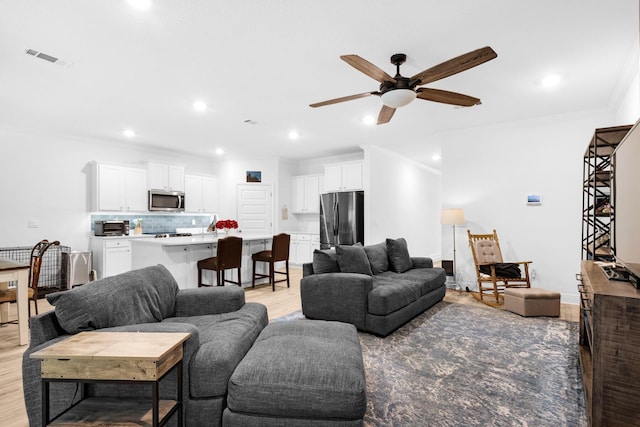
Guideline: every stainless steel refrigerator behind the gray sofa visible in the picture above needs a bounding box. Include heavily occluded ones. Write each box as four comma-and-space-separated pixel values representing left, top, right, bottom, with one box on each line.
320, 191, 364, 249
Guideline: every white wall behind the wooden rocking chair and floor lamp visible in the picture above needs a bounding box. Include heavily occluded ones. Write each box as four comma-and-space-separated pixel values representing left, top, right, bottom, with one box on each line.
441, 111, 617, 303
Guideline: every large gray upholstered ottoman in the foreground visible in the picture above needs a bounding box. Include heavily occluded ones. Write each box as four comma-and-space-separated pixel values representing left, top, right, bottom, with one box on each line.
222, 320, 367, 427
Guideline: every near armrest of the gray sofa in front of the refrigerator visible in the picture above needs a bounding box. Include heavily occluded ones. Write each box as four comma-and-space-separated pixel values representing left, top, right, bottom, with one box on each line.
300, 273, 373, 329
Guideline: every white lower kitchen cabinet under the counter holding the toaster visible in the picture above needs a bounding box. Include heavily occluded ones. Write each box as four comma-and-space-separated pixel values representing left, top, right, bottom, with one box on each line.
89, 237, 131, 279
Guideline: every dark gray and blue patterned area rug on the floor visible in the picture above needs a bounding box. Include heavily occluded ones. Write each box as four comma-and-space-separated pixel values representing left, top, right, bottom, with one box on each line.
278, 302, 587, 427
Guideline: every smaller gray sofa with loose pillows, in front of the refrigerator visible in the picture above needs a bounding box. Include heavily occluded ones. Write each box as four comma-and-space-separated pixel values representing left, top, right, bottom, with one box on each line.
300, 238, 446, 336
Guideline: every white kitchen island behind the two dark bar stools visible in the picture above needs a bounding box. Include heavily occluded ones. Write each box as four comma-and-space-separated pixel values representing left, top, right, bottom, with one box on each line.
131, 233, 273, 289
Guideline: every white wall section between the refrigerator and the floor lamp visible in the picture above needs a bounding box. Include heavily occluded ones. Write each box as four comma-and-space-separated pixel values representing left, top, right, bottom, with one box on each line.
363, 146, 441, 259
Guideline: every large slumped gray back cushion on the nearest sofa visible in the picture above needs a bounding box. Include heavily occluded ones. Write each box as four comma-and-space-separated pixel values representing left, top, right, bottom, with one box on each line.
47, 265, 178, 334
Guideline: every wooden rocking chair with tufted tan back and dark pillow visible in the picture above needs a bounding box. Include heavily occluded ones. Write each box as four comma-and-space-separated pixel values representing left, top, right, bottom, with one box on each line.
467, 230, 532, 305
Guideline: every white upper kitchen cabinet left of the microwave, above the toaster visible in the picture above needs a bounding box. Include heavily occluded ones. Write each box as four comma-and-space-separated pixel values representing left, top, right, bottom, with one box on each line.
91, 163, 147, 212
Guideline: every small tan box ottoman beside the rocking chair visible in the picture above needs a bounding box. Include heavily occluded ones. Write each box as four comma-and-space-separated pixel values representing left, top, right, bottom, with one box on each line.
504, 288, 560, 317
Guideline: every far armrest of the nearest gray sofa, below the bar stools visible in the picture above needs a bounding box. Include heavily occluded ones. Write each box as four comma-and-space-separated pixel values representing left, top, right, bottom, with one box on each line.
174, 286, 245, 317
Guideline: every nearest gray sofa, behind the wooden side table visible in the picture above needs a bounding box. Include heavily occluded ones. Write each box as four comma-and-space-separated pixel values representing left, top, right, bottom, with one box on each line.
22, 265, 268, 427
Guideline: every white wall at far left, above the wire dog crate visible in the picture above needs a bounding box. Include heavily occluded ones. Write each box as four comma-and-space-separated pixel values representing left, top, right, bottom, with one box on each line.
0, 127, 215, 251
